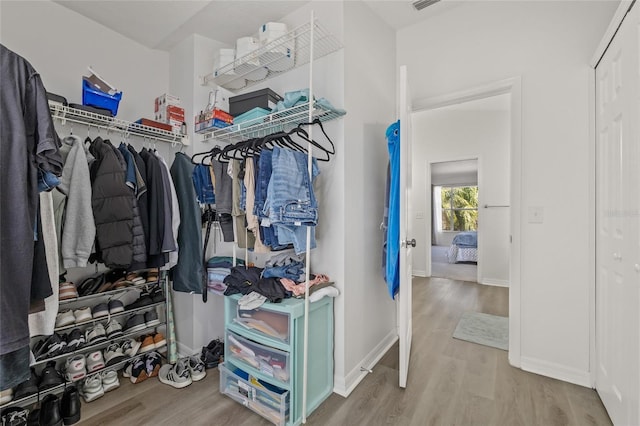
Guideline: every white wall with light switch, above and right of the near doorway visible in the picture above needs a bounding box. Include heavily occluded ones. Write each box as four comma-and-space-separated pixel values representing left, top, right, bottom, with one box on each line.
397, 1, 617, 385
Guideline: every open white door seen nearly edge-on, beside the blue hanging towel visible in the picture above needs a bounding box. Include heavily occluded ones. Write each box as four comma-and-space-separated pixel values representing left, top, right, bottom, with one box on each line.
398, 65, 416, 388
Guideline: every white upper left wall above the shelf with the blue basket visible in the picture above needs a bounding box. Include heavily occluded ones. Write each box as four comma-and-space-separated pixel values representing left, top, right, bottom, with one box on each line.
0, 1, 169, 125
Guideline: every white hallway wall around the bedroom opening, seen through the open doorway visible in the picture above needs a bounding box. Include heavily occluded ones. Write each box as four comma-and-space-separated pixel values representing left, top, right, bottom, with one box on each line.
412, 108, 510, 285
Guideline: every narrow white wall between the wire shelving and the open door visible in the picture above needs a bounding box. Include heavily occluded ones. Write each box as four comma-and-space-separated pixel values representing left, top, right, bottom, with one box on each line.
336, 2, 397, 394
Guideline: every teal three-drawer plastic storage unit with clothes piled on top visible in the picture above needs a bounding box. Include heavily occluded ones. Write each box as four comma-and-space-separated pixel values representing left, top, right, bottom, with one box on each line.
220, 295, 333, 426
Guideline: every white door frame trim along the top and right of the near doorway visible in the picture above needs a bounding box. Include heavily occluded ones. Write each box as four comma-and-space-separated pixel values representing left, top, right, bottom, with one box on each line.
412, 76, 522, 368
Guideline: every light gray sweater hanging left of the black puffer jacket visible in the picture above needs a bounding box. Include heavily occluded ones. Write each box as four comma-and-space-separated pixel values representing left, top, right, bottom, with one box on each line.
57, 135, 96, 268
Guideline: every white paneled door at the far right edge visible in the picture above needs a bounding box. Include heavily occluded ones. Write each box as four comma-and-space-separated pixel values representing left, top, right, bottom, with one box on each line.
596, 2, 640, 425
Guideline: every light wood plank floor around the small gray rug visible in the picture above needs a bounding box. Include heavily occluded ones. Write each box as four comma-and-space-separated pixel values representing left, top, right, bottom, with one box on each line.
80, 278, 611, 426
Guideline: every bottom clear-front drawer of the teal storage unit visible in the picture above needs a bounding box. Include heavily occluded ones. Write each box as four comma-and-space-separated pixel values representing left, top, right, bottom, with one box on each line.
218, 363, 289, 425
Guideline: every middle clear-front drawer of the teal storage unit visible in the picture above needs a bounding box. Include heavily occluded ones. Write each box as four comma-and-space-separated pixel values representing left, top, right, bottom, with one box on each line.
225, 330, 291, 384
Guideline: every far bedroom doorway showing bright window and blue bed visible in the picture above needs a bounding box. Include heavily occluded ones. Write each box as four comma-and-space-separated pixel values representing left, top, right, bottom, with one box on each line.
427, 158, 479, 282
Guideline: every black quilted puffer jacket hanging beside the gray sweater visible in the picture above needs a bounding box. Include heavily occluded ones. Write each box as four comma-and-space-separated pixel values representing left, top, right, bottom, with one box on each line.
89, 137, 133, 268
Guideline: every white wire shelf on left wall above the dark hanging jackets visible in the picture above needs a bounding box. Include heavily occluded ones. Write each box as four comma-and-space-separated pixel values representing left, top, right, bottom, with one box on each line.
49, 103, 188, 145
